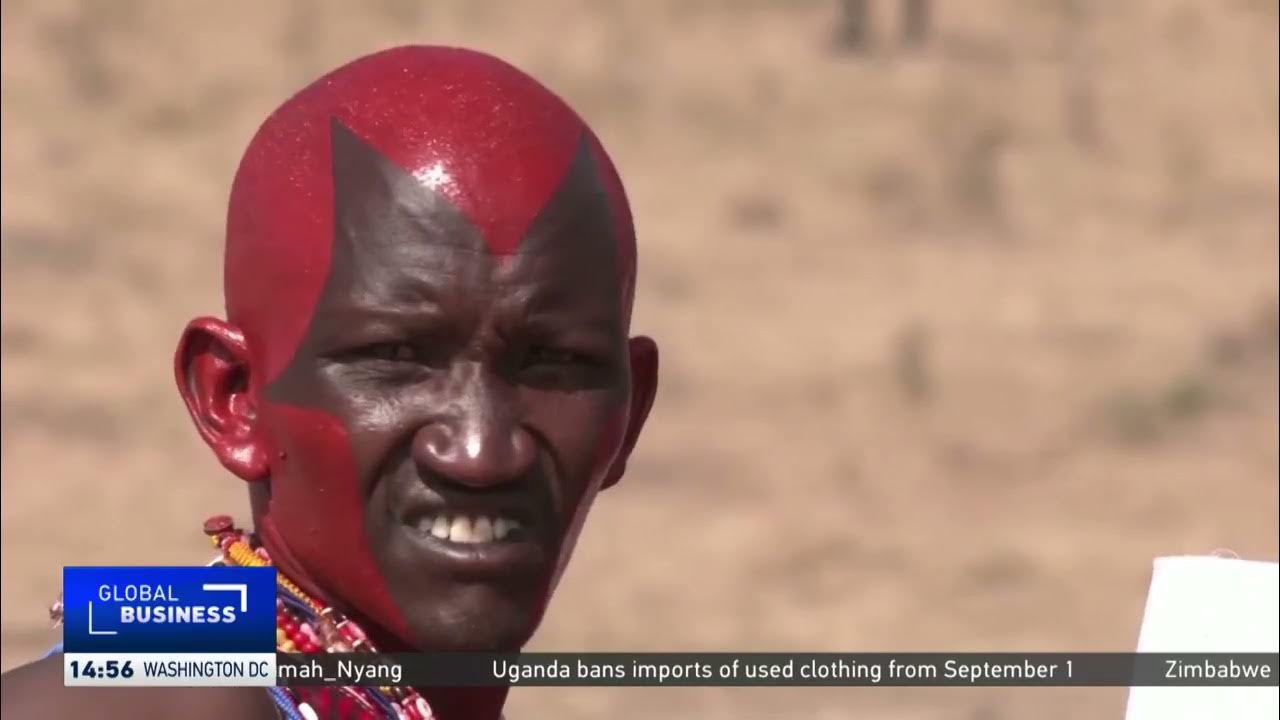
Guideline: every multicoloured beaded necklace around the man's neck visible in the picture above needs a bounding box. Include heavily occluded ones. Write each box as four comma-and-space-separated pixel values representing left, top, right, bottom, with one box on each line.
205, 515, 434, 720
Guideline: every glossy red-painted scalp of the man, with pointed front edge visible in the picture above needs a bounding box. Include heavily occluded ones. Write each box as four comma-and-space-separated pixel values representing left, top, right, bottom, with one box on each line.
224, 46, 635, 384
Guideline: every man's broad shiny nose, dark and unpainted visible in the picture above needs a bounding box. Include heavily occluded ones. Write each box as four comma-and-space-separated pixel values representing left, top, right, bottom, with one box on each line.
413, 374, 538, 489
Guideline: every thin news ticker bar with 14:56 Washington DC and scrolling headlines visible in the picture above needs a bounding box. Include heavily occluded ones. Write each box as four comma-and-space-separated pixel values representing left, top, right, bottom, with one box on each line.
64, 652, 1280, 688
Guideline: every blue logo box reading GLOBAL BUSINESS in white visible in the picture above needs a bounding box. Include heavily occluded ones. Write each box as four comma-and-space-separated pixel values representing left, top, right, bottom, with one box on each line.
63, 568, 275, 652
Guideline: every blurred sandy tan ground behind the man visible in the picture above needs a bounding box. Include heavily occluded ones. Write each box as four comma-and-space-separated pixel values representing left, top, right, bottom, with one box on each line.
0, 0, 1280, 720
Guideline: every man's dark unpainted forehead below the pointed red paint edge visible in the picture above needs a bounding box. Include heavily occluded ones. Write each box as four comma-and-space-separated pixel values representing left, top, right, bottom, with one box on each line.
326, 120, 622, 313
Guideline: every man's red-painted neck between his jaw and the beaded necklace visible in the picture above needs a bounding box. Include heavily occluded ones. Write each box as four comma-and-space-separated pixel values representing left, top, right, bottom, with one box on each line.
255, 516, 509, 720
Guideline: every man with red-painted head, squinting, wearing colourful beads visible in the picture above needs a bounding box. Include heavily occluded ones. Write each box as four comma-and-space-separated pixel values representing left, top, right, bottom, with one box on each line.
4, 47, 658, 720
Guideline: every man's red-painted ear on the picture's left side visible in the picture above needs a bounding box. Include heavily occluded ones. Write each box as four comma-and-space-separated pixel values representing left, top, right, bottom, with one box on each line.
173, 318, 270, 482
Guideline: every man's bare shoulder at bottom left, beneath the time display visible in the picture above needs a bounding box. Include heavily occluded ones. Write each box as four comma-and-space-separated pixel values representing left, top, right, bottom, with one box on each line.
0, 655, 279, 720
